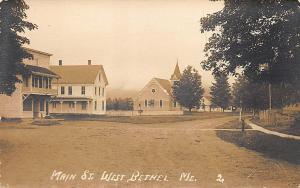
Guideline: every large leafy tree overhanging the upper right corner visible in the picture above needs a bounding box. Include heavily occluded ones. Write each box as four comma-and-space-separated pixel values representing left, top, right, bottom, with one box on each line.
200, 0, 300, 84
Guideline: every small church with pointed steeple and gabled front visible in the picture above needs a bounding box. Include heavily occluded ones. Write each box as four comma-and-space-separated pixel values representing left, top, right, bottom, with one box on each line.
134, 62, 182, 114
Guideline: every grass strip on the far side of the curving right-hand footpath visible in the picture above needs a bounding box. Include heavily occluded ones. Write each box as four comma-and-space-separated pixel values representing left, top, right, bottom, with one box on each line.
252, 119, 300, 136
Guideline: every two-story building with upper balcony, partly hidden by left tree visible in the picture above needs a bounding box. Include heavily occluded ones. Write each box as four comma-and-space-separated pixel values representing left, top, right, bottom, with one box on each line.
0, 48, 59, 118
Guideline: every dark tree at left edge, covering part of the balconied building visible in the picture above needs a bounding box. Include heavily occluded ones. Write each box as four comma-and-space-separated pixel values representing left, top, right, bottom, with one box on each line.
0, 0, 37, 95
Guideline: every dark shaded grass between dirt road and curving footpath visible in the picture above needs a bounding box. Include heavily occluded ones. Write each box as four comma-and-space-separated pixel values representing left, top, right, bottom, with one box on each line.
216, 131, 300, 165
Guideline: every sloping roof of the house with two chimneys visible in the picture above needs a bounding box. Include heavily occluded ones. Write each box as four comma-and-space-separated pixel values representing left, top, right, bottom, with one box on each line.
50, 65, 108, 85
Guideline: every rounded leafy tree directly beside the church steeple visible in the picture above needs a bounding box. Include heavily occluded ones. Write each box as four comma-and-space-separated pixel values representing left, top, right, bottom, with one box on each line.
172, 66, 204, 111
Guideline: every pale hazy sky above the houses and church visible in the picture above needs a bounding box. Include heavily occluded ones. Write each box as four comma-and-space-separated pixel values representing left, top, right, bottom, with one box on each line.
26, 0, 223, 90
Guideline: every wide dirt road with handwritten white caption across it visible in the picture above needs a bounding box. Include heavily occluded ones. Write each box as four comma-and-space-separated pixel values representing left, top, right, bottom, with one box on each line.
0, 117, 300, 188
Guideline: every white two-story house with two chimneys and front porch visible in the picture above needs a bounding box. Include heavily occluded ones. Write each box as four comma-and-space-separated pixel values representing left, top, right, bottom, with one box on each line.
50, 60, 108, 115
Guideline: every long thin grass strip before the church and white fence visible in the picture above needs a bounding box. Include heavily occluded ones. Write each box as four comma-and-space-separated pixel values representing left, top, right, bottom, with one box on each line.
51, 112, 235, 124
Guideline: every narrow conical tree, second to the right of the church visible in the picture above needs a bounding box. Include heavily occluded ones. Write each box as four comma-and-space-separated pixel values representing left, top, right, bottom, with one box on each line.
210, 75, 231, 111
